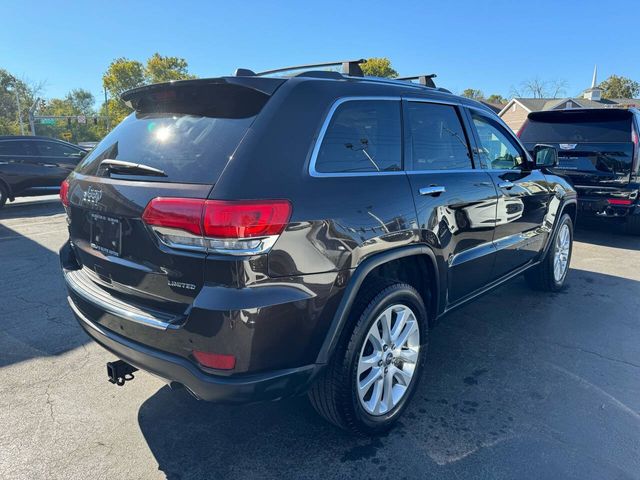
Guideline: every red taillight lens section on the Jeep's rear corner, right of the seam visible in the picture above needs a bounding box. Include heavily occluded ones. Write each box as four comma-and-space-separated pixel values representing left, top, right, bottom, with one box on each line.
204, 200, 291, 238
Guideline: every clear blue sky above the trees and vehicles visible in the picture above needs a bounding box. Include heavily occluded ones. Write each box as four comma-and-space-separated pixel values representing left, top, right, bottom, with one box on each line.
0, 0, 640, 102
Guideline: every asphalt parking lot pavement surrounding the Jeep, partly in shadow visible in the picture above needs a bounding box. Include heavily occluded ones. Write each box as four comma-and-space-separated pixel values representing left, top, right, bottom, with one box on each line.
0, 197, 640, 480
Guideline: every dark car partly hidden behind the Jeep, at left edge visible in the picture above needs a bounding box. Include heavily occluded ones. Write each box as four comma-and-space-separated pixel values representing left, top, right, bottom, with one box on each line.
0, 136, 87, 208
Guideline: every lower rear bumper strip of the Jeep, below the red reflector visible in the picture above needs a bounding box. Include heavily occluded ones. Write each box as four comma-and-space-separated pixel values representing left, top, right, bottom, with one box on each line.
68, 297, 322, 403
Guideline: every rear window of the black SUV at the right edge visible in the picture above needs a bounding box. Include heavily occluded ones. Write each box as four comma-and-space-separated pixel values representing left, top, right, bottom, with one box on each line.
520, 110, 632, 143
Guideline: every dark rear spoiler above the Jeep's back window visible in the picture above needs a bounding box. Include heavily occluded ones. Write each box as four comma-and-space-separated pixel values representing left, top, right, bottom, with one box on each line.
120, 77, 286, 118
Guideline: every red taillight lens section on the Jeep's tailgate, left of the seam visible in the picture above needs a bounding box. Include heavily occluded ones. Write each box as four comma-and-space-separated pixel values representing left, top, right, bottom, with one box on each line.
142, 197, 205, 235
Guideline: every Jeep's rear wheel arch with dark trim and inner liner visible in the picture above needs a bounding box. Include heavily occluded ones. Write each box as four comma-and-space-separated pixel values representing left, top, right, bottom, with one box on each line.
317, 245, 440, 363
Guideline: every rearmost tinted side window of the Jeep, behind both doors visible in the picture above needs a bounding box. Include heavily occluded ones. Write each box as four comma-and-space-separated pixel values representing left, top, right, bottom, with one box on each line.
315, 100, 402, 173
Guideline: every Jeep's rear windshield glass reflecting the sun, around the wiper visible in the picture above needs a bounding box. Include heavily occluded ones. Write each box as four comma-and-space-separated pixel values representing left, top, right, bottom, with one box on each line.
77, 112, 255, 184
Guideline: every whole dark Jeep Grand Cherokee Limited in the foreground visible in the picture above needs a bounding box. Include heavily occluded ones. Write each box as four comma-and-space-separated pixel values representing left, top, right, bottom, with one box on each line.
60, 61, 576, 433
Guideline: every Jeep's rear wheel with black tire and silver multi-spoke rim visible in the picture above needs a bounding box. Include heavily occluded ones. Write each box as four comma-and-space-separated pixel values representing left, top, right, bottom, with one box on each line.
309, 279, 428, 435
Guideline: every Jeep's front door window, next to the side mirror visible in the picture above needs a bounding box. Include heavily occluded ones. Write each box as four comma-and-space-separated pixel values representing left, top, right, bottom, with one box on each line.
471, 112, 524, 170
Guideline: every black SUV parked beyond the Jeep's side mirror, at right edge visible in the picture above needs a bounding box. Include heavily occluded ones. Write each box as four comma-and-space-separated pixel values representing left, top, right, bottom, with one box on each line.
518, 109, 640, 234
